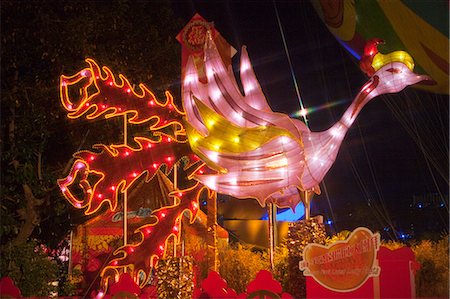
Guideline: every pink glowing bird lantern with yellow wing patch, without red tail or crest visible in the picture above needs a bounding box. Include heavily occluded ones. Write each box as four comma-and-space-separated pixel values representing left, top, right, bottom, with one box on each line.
183, 34, 430, 208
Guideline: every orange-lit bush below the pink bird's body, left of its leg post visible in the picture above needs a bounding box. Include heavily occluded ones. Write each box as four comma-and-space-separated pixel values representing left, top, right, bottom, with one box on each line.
219, 244, 270, 294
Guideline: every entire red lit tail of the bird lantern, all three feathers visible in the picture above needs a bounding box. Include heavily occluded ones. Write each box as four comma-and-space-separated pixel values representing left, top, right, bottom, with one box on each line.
58, 59, 209, 294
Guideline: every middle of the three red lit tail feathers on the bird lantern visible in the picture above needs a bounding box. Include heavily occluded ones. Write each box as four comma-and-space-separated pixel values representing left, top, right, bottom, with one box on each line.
58, 136, 191, 215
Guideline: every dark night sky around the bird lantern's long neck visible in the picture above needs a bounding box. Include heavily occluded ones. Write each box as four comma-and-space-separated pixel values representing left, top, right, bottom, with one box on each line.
173, 1, 449, 239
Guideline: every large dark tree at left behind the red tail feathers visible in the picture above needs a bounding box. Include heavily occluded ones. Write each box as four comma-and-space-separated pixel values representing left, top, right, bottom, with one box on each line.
0, 0, 182, 296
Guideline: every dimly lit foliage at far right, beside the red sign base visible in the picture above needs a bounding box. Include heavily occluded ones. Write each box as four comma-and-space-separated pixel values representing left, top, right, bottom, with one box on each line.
411, 235, 449, 298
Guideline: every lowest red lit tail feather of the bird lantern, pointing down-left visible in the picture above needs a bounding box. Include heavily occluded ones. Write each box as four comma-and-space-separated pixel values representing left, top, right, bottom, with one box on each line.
101, 184, 212, 287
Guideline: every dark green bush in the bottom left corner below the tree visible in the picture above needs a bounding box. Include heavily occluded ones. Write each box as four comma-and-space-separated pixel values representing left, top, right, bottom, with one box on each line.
0, 241, 58, 297
